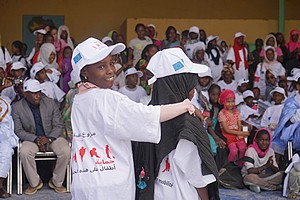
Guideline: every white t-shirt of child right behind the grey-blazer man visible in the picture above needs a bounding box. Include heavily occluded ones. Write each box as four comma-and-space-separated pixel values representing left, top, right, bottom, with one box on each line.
41, 81, 66, 102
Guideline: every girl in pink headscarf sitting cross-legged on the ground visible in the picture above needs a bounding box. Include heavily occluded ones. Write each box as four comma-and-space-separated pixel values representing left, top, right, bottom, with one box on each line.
241, 128, 282, 193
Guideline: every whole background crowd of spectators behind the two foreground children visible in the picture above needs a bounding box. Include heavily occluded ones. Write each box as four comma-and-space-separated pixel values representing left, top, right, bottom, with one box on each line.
0, 24, 300, 198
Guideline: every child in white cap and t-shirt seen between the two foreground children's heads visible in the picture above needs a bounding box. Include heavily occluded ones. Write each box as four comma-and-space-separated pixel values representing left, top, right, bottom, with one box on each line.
119, 67, 147, 103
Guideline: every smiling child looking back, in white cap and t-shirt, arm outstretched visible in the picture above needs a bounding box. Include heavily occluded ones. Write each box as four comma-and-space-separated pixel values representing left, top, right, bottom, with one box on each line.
71, 38, 194, 200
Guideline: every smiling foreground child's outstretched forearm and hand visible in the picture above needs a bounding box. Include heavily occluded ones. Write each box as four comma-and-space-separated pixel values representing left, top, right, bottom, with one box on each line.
159, 99, 195, 122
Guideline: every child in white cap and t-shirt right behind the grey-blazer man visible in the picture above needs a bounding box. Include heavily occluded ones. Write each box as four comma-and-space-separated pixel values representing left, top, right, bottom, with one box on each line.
30, 62, 66, 102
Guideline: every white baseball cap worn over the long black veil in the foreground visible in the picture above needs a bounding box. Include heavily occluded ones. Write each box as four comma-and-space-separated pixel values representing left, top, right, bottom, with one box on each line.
147, 48, 208, 85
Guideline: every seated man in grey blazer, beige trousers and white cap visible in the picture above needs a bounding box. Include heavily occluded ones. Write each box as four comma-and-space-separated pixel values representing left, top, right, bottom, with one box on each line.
12, 79, 70, 194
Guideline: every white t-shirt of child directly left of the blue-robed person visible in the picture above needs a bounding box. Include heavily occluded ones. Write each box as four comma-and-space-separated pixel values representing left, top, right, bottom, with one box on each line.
260, 104, 284, 133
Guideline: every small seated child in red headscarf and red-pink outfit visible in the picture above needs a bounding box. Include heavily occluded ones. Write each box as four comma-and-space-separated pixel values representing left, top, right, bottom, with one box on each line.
218, 90, 249, 166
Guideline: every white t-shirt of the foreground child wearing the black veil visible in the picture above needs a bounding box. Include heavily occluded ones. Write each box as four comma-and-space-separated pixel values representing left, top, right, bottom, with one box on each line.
154, 139, 216, 200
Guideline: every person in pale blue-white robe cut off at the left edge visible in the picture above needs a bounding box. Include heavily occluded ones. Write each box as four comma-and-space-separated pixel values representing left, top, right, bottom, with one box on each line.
0, 96, 18, 198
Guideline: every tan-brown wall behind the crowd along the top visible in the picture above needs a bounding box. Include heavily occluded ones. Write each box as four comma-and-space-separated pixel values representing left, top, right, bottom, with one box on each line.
0, 0, 300, 49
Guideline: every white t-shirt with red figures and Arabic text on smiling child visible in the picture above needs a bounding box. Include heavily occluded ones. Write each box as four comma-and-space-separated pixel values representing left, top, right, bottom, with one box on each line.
71, 88, 161, 200
